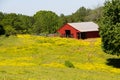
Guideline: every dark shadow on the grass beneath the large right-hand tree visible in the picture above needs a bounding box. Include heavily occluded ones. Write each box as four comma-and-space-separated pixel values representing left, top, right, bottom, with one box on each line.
106, 58, 120, 68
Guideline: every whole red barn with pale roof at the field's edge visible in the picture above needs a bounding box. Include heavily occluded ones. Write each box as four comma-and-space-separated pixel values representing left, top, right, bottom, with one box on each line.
58, 22, 99, 39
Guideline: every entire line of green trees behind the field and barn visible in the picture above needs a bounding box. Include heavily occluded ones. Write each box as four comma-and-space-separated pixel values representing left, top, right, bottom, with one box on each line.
0, 7, 102, 35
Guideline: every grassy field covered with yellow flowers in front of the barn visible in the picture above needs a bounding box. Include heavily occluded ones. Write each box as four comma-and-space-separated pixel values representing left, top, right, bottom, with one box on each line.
0, 35, 120, 80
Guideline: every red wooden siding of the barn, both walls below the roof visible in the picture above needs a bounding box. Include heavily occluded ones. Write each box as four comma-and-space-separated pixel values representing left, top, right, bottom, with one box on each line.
58, 24, 99, 39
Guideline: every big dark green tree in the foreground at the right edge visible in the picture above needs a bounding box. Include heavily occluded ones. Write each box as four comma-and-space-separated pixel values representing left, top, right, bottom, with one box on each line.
100, 0, 120, 55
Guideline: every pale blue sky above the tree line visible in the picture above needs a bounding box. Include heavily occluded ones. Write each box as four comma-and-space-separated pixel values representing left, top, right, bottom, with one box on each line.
0, 0, 105, 16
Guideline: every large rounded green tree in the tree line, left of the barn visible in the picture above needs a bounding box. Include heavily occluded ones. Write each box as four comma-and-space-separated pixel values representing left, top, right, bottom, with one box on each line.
33, 11, 59, 34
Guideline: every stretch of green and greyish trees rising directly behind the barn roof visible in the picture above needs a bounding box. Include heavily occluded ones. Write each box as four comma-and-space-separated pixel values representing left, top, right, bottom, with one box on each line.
60, 7, 102, 25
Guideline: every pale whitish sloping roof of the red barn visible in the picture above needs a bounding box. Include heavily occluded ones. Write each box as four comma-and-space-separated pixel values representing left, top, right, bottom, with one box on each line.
68, 22, 99, 32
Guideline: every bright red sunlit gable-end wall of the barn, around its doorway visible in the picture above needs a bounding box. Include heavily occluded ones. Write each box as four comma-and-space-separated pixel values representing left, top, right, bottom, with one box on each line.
58, 24, 79, 38
